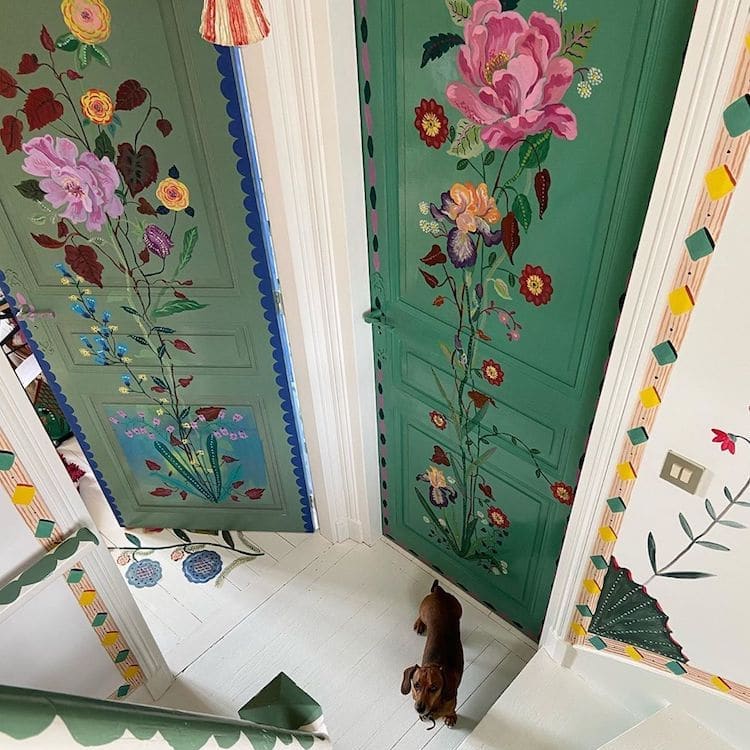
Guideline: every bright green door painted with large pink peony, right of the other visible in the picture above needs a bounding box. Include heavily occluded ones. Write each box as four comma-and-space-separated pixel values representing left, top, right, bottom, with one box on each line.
356, 0, 695, 635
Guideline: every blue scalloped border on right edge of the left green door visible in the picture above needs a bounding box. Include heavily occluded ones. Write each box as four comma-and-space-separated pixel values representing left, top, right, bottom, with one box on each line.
215, 45, 315, 531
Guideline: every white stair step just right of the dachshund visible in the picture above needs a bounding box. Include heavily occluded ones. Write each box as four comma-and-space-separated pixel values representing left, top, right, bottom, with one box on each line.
459, 651, 636, 750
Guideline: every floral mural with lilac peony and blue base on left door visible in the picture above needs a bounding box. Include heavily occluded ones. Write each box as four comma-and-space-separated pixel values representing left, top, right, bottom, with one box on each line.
0, 0, 266, 504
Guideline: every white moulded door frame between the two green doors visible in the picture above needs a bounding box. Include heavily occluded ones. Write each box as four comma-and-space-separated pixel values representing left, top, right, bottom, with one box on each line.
242, 0, 381, 544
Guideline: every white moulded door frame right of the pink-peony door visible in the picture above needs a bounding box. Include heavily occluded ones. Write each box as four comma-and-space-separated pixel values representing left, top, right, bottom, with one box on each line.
540, 0, 750, 663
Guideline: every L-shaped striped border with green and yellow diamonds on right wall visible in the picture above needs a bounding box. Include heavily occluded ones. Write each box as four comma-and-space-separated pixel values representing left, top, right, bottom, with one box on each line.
569, 25, 750, 702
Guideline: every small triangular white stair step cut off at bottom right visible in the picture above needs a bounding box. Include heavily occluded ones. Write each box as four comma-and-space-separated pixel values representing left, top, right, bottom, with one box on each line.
599, 706, 735, 750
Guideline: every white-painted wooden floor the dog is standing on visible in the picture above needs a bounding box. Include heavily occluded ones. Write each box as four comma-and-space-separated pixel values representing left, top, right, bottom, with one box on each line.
122, 534, 534, 750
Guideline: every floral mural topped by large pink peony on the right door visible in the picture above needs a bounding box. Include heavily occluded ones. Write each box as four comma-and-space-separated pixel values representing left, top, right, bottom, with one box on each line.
414, 0, 603, 575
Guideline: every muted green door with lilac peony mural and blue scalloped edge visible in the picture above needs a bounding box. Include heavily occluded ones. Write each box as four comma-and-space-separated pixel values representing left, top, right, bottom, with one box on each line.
0, 0, 312, 531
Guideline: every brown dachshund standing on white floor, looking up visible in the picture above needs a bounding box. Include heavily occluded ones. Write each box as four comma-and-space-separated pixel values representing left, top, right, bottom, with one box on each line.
401, 580, 464, 728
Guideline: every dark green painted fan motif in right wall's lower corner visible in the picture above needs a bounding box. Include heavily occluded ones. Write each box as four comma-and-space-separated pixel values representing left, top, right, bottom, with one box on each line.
589, 557, 688, 662
